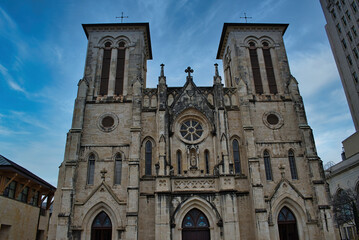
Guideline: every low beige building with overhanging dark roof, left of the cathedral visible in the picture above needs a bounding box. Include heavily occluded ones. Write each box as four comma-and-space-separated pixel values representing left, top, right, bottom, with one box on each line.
0, 155, 56, 240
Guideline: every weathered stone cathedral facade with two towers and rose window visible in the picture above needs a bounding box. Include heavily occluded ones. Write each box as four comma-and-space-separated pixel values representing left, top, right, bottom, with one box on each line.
49, 23, 336, 240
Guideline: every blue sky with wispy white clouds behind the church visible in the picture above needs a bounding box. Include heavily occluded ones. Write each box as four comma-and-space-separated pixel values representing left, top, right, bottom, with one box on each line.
0, 0, 354, 185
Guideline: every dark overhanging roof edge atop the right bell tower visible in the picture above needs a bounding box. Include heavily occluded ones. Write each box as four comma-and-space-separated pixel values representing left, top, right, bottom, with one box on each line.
217, 23, 289, 59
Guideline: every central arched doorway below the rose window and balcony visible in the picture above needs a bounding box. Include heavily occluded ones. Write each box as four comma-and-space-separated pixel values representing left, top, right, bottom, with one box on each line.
182, 208, 211, 240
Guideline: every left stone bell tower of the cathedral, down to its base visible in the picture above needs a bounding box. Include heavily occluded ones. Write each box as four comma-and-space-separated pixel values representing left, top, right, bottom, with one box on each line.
49, 23, 152, 239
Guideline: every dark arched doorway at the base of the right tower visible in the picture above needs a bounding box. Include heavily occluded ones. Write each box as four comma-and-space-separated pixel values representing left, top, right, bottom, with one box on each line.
278, 207, 299, 240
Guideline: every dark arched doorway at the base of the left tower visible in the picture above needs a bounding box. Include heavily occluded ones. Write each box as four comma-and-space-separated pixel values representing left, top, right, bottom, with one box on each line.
91, 211, 112, 240
